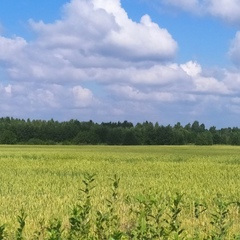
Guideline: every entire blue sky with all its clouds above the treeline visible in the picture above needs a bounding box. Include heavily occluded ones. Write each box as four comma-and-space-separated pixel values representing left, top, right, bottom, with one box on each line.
0, 0, 240, 128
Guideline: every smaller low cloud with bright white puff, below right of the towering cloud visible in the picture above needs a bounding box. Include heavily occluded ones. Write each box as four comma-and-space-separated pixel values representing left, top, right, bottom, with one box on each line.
104, 61, 231, 109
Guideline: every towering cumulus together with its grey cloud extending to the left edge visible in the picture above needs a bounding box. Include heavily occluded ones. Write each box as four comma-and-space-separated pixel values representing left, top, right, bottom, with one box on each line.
0, 0, 177, 81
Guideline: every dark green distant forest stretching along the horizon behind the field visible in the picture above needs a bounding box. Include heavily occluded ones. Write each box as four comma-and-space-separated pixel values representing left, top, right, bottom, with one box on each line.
0, 117, 240, 145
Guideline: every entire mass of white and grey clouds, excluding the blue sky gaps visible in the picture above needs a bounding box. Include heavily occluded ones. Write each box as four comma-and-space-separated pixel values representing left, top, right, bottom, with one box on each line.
0, 0, 240, 126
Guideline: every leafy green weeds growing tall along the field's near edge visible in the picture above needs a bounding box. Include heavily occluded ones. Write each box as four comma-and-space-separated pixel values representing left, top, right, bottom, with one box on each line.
0, 174, 240, 240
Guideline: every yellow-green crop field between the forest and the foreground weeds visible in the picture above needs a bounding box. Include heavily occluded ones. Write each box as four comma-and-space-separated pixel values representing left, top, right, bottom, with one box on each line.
0, 145, 240, 239
